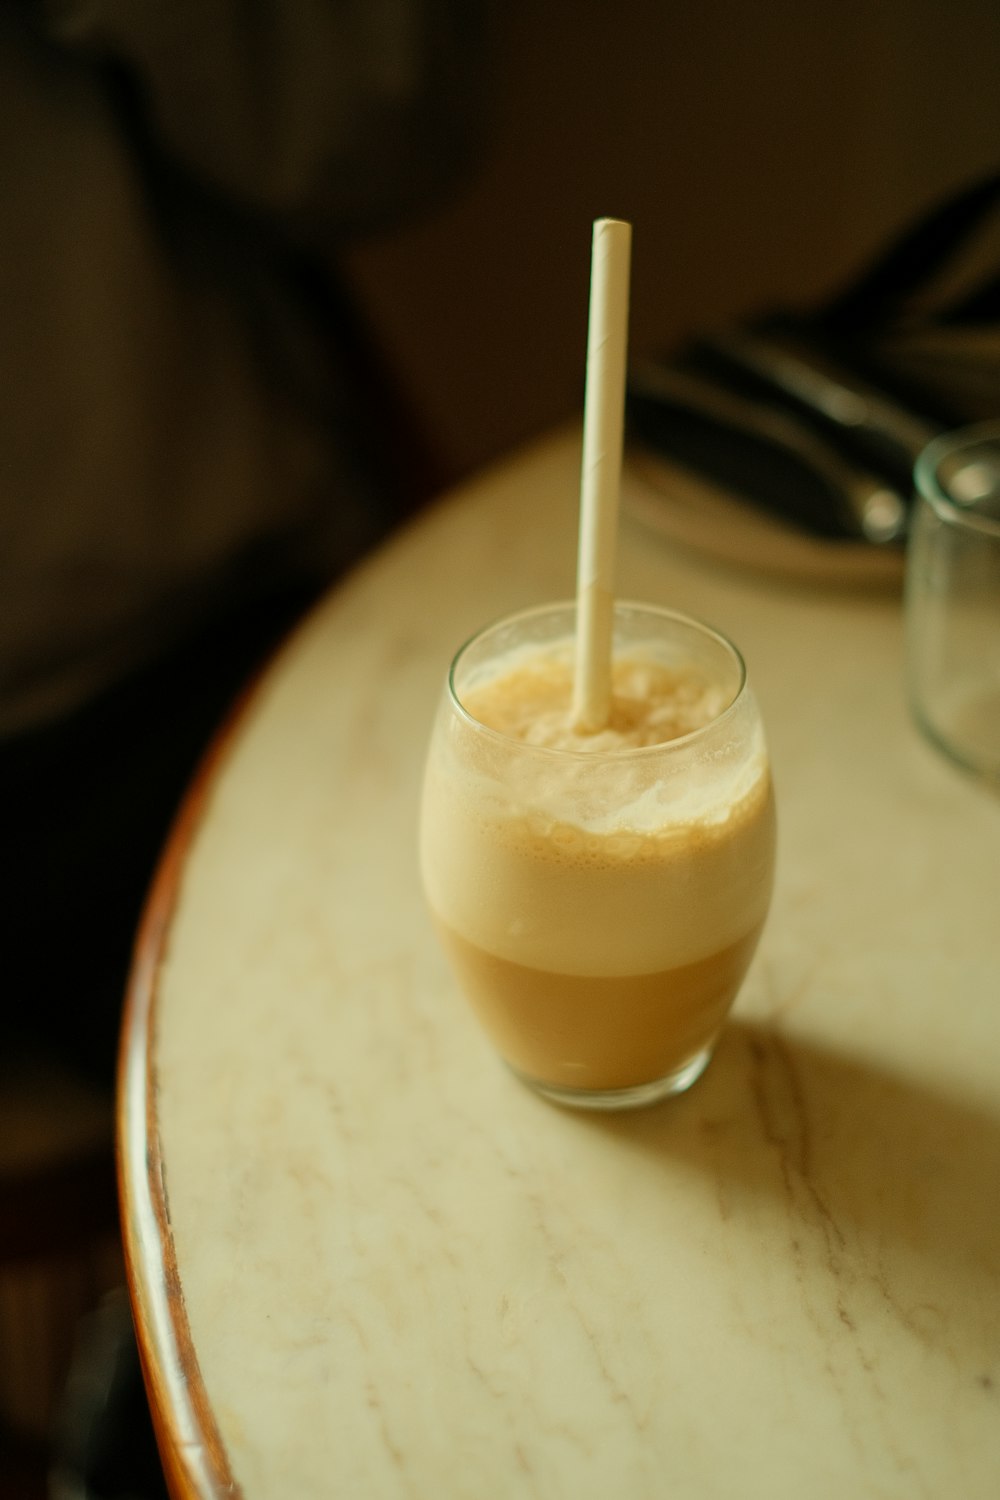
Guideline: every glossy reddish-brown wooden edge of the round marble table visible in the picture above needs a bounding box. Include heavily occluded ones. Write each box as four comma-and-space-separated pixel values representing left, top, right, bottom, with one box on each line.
115, 684, 262, 1500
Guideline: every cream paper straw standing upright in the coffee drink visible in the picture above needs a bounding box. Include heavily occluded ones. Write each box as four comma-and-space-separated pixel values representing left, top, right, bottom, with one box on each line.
573, 219, 631, 734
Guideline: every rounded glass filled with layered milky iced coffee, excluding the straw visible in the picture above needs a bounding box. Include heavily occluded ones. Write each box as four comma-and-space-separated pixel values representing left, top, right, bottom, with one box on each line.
421, 603, 775, 1109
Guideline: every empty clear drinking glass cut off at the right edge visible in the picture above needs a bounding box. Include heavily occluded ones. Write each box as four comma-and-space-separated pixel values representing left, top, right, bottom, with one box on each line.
906, 423, 1000, 785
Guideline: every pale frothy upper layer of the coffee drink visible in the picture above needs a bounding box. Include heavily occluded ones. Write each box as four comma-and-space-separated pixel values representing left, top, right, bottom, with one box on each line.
421, 642, 774, 977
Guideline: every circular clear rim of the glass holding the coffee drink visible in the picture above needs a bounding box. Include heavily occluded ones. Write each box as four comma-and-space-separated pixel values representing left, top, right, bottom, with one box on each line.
447, 599, 748, 761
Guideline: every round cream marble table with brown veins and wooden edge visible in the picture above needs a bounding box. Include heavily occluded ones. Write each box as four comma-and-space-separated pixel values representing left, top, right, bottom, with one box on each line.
118, 432, 1000, 1500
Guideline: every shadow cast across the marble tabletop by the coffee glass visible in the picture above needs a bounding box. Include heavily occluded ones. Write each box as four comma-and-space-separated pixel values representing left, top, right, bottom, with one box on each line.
575, 1022, 1000, 1397
